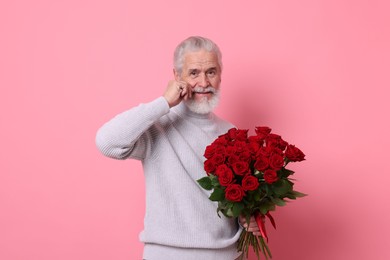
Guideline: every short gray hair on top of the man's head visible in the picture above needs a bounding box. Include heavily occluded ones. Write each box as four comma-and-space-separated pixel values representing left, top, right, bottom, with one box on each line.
173, 36, 222, 74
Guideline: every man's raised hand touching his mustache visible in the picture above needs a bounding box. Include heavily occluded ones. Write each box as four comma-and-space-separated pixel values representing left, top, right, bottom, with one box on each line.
163, 80, 192, 107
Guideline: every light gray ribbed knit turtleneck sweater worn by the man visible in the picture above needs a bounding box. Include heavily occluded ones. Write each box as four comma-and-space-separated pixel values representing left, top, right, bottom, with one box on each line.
96, 97, 241, 260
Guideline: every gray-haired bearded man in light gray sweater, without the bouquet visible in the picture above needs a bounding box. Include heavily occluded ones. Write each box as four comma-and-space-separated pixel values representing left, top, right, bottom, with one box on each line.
96, 37, 259, 260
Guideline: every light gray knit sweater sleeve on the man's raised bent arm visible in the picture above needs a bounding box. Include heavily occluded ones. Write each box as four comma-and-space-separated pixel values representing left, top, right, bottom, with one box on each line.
96, 97, 169, 160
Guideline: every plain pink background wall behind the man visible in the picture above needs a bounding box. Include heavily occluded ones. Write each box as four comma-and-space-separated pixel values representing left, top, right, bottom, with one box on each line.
0, 0, 390, 260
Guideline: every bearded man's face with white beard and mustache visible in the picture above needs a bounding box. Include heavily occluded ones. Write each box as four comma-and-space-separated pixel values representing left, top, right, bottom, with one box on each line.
175, 50, 221, 113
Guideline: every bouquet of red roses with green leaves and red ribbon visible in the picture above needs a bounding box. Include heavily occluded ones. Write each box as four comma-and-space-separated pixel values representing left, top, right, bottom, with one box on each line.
198, 126, 305, 259
